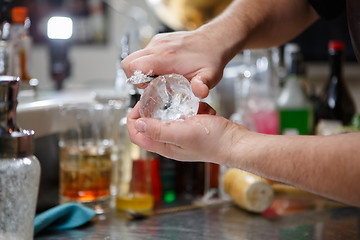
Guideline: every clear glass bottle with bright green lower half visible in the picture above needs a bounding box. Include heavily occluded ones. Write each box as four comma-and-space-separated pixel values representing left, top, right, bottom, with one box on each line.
277, 43, 313, 135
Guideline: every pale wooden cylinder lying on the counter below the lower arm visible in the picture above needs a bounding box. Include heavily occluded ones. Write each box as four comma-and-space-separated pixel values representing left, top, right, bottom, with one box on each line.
223, 168, 274, 213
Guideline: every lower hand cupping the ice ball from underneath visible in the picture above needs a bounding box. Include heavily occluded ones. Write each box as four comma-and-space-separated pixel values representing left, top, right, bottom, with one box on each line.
127, 103, 249, 164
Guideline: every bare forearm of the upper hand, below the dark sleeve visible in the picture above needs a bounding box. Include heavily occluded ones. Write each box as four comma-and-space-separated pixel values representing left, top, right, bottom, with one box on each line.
199, 0, 318, 61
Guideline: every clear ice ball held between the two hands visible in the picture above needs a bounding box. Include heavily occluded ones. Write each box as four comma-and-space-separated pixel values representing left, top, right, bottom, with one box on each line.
140, 74, 199, 121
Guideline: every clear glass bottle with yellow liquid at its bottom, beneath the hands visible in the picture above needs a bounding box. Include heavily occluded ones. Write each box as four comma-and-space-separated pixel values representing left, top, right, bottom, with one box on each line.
116, 93, 160, 212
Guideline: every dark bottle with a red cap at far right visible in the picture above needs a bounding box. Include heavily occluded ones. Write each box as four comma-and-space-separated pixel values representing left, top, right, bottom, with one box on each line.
316, 41, 356, 125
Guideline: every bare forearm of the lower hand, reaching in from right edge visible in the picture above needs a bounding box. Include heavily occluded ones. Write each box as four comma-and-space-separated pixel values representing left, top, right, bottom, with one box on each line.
228, 133, 360, 206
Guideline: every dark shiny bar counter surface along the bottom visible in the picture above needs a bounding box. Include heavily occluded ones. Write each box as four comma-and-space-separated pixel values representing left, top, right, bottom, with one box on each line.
35, 202, 360, 240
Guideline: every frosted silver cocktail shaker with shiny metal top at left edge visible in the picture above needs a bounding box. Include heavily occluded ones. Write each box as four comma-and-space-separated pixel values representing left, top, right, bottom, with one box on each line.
0, 76, 40, 239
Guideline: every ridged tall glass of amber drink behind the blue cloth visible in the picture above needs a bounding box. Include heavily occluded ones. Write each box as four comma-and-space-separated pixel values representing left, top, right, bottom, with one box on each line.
59, 103, 113, 214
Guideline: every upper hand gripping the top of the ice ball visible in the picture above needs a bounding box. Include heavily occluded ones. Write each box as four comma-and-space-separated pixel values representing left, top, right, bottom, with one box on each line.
121, 30, 226, 98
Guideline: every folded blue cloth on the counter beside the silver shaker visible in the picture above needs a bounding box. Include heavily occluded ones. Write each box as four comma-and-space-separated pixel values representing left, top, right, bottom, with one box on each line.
34, 203, 96, 235
